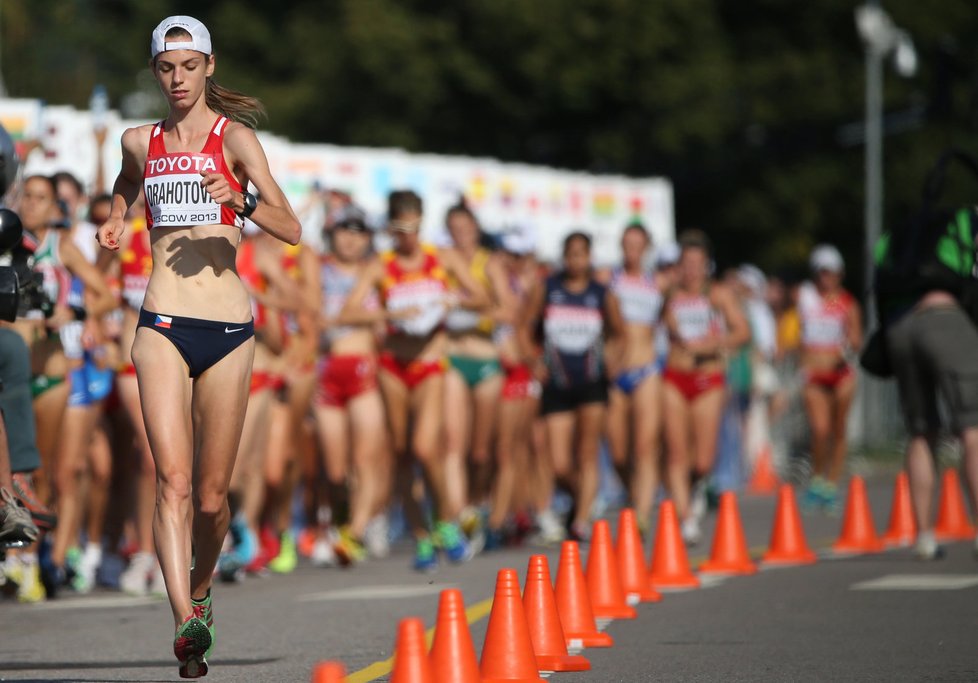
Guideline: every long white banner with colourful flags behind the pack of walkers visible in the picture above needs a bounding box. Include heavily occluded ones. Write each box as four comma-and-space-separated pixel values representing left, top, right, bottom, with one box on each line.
0, 99, 675, 265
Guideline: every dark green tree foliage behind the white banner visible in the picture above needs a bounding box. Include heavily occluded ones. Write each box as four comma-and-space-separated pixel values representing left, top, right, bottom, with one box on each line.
0, 0, 978, 289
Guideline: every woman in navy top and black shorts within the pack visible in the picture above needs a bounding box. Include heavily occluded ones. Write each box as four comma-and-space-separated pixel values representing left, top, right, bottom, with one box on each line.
520, 232, 623, 540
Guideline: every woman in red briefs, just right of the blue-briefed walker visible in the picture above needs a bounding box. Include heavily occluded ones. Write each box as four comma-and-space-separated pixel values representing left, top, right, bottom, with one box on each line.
663, 230, 750, 544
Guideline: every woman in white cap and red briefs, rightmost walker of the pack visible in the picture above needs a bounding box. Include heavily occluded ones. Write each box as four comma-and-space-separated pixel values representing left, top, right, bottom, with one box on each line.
798, 244, 862, 513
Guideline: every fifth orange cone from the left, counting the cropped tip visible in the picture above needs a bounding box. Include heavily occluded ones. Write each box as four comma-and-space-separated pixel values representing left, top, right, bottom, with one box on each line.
528, 555, 591, 671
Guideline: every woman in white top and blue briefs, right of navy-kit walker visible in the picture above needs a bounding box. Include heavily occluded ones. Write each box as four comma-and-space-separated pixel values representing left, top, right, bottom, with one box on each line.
603, 223, 664, 531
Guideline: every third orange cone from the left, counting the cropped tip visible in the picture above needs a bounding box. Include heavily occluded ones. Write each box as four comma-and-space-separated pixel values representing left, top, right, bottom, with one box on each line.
428, 588, 482, 683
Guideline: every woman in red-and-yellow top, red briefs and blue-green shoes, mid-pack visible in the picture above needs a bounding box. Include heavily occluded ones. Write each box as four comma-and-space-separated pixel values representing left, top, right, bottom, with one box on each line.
342, 190, 489, 571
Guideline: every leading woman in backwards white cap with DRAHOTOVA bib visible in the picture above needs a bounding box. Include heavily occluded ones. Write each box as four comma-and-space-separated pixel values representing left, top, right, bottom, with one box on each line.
98, 16, 300, 678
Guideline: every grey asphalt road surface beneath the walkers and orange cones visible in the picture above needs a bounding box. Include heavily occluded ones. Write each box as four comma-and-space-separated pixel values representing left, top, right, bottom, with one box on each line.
0, 476, 978, 683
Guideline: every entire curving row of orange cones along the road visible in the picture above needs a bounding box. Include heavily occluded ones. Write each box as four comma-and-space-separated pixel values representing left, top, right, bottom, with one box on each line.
312, 470, 975, 683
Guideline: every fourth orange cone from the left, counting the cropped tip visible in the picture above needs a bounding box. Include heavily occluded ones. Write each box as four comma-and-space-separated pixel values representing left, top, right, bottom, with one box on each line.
481, 569, 544, 683
